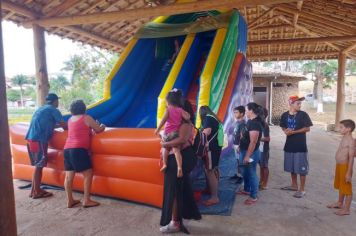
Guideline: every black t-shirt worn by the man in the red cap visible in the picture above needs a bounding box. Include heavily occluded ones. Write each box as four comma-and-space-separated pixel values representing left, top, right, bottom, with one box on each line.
280, 111, 313, 153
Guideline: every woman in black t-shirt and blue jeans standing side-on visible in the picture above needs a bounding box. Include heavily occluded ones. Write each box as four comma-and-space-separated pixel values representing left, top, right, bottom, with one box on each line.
239, 103, 264, 205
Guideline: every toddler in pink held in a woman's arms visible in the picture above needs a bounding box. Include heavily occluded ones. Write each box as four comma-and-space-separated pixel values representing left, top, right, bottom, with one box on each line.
155, 89, 190, 177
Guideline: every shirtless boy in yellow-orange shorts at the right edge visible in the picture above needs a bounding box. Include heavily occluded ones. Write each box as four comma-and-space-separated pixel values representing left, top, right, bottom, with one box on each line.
327, 120, 355, 216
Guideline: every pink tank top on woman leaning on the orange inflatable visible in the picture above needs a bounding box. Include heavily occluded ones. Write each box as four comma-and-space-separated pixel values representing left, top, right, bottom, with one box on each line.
64, 115, 91, 149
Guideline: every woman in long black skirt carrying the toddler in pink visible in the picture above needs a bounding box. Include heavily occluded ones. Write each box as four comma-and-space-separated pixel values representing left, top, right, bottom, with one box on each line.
160, 98, 201, 233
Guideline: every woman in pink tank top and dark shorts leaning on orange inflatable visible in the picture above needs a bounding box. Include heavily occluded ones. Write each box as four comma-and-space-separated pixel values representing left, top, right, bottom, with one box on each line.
64, 100, 105, 208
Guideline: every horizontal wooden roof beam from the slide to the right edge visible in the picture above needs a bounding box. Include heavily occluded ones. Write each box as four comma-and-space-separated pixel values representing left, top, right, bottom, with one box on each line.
248, 35, 356, 46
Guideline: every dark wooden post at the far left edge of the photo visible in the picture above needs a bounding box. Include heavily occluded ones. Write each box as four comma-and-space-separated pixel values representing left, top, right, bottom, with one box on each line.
0, 1, 17, 236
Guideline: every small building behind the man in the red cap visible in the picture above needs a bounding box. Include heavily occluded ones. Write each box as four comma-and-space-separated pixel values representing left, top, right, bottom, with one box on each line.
253, 77, 300, 125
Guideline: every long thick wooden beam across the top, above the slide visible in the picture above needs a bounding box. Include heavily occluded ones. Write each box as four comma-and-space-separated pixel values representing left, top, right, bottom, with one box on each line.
24, 0, 295, 27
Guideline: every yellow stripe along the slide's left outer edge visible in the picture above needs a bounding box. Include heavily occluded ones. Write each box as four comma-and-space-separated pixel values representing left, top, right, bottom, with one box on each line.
88, 38, 137, 108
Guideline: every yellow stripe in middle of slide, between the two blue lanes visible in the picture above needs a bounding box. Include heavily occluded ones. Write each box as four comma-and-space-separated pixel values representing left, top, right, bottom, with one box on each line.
157, 34, 195, 126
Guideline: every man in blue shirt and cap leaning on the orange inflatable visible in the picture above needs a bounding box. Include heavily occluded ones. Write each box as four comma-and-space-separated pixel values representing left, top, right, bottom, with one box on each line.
25, 93, 67, 199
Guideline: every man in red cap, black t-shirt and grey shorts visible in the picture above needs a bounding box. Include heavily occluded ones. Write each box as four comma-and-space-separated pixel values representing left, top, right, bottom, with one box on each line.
280, 96, 313, 198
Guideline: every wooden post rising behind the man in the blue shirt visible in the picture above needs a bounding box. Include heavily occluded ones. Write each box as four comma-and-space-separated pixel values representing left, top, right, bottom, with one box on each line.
33, 25, 49, 106
